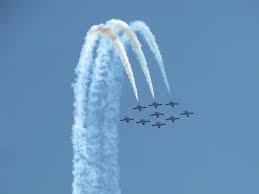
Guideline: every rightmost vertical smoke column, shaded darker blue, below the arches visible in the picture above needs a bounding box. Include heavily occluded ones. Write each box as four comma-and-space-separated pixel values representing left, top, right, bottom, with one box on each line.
96, 38, 123, 194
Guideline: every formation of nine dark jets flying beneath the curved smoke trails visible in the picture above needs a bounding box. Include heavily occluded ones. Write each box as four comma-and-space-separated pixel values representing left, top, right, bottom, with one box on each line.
120, 101, 194, 128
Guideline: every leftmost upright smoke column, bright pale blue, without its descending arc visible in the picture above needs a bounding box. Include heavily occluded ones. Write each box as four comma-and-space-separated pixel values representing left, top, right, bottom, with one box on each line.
72, 26, 103, 194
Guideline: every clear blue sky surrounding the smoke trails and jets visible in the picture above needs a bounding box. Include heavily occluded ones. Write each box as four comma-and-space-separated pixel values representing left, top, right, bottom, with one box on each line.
0, 0, 259, 194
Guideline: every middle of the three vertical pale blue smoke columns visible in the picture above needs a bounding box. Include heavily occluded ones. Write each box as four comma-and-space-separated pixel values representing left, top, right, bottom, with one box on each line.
78, 37, 109, 194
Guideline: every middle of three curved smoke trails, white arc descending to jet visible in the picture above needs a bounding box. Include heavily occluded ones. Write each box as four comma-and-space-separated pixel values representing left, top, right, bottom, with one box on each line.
106, 19, 154, 98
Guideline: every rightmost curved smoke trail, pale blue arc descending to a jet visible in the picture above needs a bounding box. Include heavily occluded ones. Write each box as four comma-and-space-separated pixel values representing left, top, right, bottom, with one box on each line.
130, 21, 171, 95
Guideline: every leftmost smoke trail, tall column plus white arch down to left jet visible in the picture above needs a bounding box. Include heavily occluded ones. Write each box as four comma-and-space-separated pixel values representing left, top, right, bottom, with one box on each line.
72, 25, 138, 194
